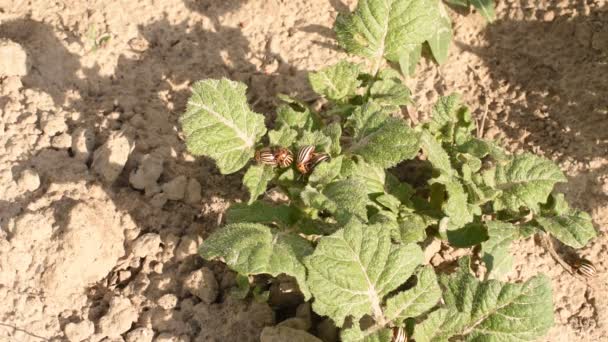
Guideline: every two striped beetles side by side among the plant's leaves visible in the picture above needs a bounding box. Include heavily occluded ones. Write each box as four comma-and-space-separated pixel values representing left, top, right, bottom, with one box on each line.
255, 145, 330, 174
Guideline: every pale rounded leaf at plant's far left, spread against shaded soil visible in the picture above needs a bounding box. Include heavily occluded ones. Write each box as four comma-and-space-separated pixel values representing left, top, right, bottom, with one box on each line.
180, 79, 266, 174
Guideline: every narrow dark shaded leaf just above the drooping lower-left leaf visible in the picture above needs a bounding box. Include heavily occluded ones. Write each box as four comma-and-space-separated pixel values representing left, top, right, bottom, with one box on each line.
226, 201, 298, 226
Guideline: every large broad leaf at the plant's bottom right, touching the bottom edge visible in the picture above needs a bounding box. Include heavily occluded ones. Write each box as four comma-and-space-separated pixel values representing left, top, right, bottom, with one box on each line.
414, 270, 553, 342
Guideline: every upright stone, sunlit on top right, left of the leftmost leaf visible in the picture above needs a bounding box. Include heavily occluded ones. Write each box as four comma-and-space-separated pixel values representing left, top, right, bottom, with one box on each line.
92, 132, 133, 183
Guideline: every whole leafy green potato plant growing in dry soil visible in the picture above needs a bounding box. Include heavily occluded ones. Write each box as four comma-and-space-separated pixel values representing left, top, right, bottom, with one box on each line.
181, 0, 596, 342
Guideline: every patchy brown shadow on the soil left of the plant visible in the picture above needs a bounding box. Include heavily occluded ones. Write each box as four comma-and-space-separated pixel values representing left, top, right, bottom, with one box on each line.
0, 0, 306, 336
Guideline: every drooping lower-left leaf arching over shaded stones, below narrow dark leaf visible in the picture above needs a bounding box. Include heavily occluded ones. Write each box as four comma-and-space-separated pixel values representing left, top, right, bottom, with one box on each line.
199, 223, 313, 299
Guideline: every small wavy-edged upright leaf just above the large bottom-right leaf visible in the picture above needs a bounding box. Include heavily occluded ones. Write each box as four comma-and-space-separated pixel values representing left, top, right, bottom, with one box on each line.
481, 221, 519, 280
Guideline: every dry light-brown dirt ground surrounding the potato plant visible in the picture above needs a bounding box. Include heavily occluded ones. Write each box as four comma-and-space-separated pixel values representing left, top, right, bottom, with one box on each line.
0, 0, 608, 342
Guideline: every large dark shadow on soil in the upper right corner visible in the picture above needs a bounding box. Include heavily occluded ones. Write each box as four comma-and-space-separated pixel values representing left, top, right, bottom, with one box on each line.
461, 8, 608, 214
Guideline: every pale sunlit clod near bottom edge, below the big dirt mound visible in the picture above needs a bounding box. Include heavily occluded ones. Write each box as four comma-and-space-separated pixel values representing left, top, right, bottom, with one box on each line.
98, 297, 138, 337
